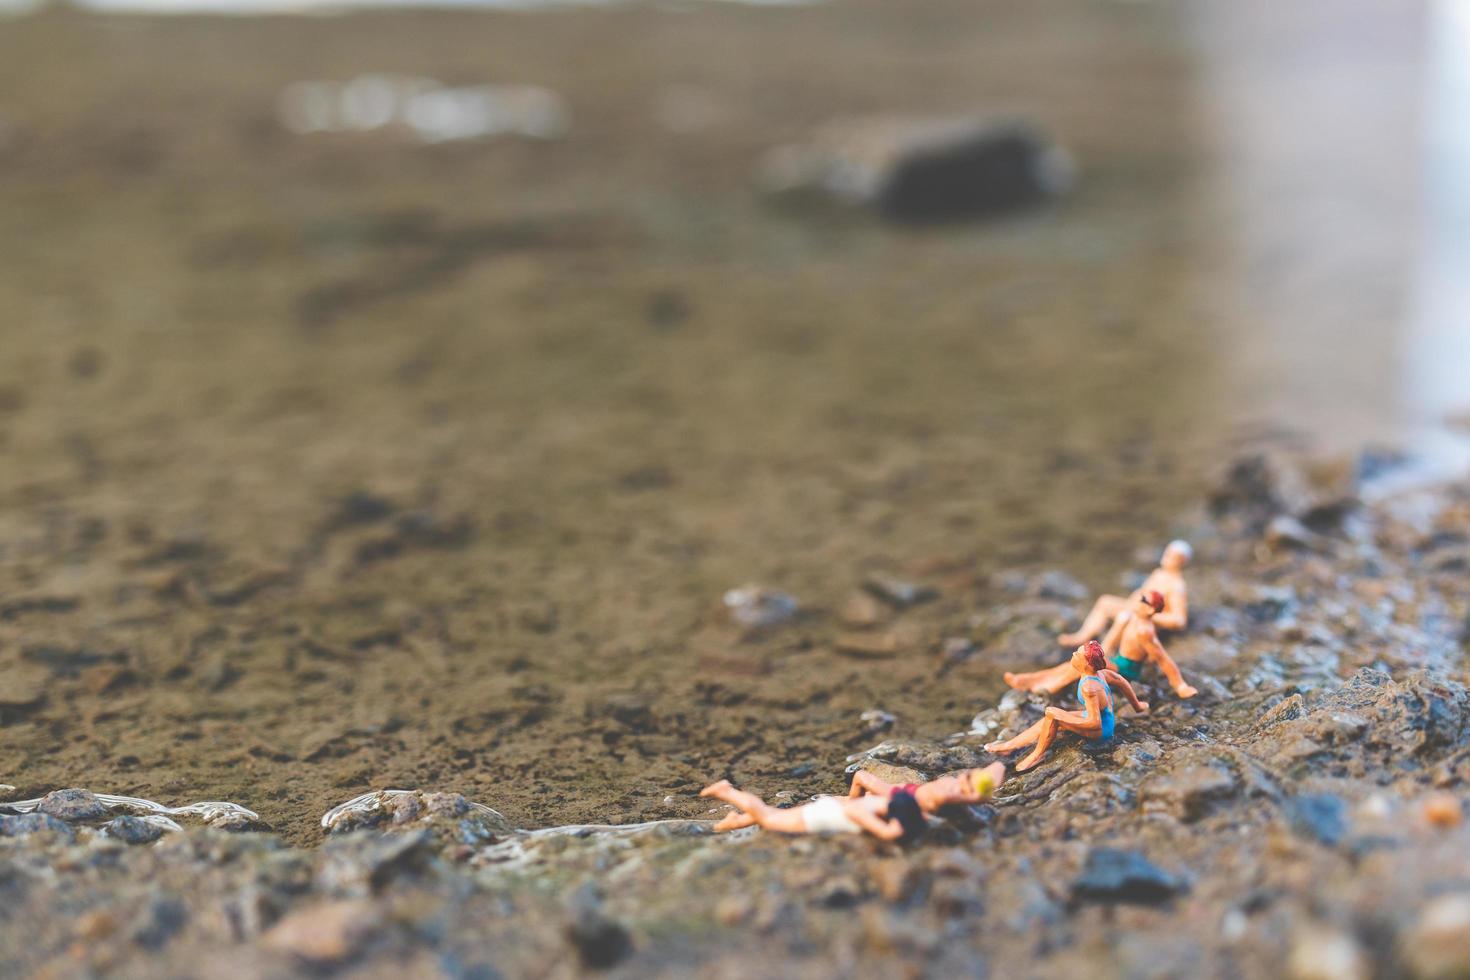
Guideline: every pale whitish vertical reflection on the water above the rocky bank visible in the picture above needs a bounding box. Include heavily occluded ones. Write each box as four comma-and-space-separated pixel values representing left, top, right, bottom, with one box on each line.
1192, 0, 1470, 476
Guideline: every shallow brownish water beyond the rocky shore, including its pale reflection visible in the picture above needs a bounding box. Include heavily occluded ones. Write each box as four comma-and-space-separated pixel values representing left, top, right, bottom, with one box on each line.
0, 0, 1470, 839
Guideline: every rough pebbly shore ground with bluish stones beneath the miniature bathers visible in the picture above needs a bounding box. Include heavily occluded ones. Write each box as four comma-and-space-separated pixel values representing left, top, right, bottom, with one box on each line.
0, 455, 1470, 977
